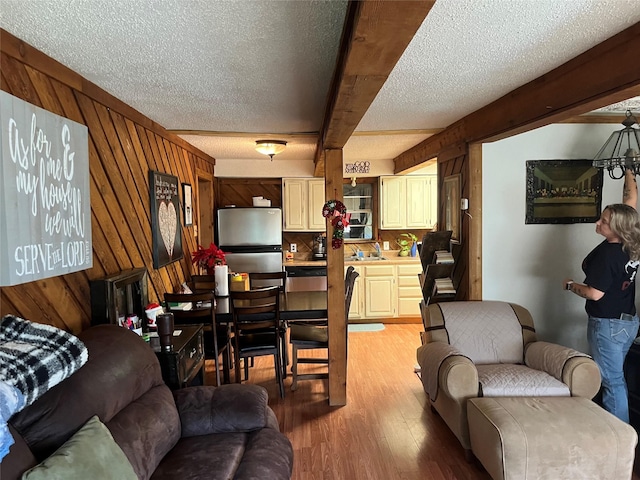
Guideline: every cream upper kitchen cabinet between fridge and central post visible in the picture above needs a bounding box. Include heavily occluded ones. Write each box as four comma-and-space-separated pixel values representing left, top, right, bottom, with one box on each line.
282, 178, 326, 232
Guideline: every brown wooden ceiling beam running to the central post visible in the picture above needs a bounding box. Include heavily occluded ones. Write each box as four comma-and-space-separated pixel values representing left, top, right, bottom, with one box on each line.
314, 0, 435, 176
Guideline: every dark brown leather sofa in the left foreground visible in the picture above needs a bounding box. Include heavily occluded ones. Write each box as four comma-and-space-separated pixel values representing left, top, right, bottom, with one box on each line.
0, 325, 293, 480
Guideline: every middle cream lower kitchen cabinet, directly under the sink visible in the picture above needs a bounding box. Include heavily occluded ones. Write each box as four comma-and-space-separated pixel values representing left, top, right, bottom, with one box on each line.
363, 264, 398, 318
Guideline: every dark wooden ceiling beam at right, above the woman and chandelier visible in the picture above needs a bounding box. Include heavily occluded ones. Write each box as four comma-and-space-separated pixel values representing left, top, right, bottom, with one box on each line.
394, 23, 640, 174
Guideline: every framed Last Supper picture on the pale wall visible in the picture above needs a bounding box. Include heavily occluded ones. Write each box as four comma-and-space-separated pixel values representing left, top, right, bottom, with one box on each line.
525, 160, 603, 224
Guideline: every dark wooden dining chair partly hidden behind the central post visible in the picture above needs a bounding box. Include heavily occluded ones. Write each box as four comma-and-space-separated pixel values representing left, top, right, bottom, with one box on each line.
289, 266, 360, 390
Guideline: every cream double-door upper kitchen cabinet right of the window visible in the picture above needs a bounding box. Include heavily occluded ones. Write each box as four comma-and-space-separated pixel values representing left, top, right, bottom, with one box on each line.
379, 175, 438, 230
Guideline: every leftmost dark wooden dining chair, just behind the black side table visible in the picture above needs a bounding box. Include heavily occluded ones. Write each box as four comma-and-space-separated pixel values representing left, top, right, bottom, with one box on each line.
164, 290, 231, 386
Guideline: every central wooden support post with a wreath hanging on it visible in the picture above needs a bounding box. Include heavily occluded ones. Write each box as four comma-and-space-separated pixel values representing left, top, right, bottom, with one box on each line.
324, 149, 347, 406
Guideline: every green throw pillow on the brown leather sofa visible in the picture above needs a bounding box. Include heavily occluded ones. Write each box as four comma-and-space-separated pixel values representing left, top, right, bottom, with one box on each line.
22, 416, 138, 480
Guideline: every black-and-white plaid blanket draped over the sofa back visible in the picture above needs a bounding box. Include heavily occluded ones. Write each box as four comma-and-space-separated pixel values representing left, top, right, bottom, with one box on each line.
0, 315, 89, 407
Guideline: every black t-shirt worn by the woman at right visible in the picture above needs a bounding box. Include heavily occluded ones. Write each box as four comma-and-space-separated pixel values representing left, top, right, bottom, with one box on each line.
582, 240, 639, 318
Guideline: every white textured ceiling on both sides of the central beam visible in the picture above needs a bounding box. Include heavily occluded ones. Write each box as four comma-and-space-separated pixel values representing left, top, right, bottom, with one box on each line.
0, 0, 640, 161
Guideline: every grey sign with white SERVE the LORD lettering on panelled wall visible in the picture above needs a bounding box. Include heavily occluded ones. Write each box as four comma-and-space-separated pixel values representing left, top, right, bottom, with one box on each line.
0, 91, 93, 286
